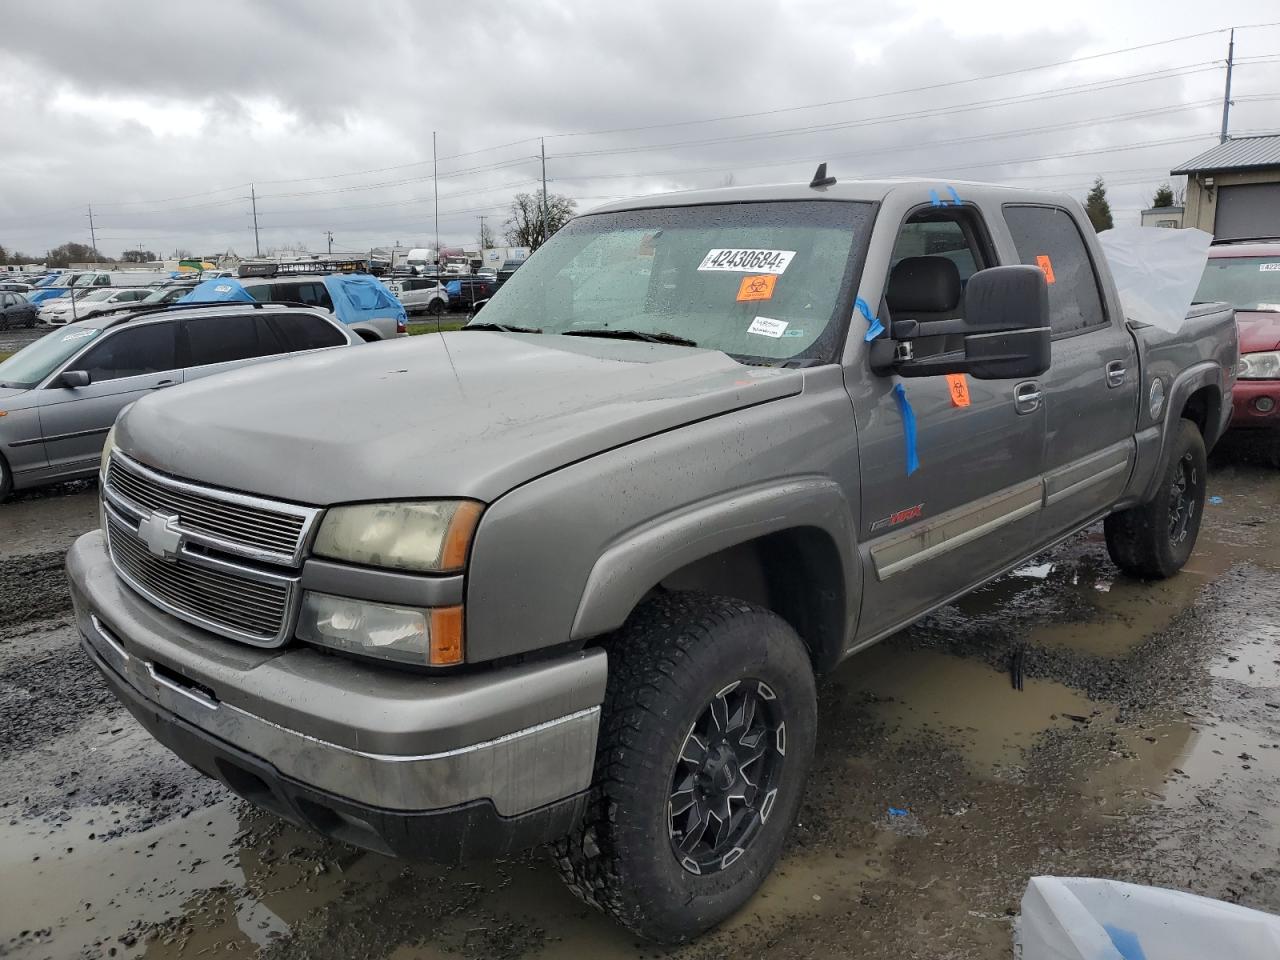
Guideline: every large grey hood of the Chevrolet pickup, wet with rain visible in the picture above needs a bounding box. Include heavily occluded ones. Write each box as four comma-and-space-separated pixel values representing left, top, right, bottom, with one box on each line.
116, 332, 803, 506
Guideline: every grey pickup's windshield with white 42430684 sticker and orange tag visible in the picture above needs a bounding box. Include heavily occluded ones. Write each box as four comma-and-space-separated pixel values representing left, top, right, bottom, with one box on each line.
475, 201, 872, 361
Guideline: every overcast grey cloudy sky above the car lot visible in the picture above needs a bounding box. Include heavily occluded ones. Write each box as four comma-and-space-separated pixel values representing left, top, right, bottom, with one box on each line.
0, 0, 1280, 256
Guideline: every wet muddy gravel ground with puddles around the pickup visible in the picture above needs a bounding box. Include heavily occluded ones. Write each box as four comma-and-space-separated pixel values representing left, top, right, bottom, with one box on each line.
0, 463, 1280, 960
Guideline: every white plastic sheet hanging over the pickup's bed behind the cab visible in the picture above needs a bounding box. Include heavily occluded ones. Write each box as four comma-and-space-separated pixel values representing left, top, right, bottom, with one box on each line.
1098, 227, 1213, 333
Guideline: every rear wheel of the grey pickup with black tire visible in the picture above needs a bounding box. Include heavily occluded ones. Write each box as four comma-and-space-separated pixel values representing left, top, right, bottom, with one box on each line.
1103, 420, 1208, 580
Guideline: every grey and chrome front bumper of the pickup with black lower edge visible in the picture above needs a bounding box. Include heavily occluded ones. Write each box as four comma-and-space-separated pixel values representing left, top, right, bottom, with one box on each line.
67, 532, 607, 860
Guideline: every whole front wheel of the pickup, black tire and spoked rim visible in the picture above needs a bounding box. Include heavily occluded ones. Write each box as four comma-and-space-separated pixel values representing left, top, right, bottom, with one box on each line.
556, 593, 817, 943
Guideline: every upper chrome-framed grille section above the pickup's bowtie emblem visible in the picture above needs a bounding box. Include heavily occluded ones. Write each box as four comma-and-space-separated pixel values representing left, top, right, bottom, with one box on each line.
104, 453, 319, 566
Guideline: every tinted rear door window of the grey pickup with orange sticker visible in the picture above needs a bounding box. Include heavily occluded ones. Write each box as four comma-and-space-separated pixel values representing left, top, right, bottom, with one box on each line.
1005, 205, 1107, 337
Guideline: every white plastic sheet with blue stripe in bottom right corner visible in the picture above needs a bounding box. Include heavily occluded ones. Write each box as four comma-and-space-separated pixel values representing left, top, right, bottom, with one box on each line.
1015, 877, 1280, 960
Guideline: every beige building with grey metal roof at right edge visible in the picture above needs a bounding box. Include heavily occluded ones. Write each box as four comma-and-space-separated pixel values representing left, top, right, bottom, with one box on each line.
1170, 134, 1280, 241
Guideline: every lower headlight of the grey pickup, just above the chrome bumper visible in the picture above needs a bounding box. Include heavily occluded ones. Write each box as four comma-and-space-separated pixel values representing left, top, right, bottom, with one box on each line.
296, 590, 462, 667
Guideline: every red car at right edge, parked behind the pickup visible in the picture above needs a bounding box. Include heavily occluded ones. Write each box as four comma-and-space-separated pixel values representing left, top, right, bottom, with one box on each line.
1196, 239, 1280, 466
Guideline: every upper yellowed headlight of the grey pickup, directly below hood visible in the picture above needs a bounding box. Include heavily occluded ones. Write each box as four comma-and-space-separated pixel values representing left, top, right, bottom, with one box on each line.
312, 500, 484, 573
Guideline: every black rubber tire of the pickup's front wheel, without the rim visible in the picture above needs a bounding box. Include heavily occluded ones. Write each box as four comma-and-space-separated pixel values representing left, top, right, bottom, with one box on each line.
553, 593, 817, 943
